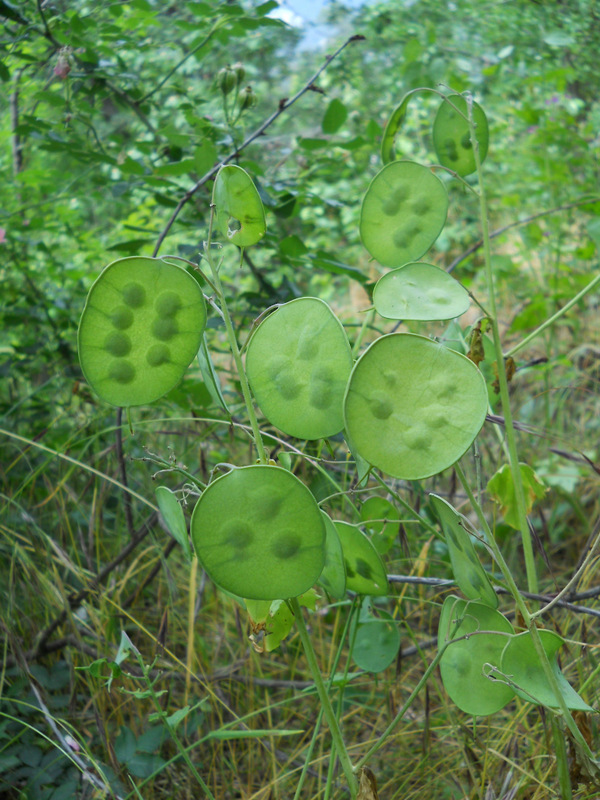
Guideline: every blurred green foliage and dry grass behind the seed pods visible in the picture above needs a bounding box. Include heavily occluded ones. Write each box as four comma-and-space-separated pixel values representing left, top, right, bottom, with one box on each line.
0, 0, 600, 800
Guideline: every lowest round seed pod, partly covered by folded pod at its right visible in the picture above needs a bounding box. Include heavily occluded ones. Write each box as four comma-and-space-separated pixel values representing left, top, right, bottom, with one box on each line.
438, 595, 515, 717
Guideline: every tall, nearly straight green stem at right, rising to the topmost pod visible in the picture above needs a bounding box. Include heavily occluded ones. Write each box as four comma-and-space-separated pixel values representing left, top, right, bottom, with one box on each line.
468, 98, 538, 594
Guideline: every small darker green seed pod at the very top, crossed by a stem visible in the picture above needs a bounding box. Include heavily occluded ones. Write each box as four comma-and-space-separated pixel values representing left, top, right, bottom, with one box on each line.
433, 94, 490, 177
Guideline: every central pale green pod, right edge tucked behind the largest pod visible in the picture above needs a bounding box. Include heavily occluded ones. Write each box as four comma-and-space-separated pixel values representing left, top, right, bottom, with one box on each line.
246, 297, 352, 439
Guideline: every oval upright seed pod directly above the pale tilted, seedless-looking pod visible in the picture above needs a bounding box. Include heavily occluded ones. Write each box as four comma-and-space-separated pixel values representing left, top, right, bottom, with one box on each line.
360, 161, 448, 267
